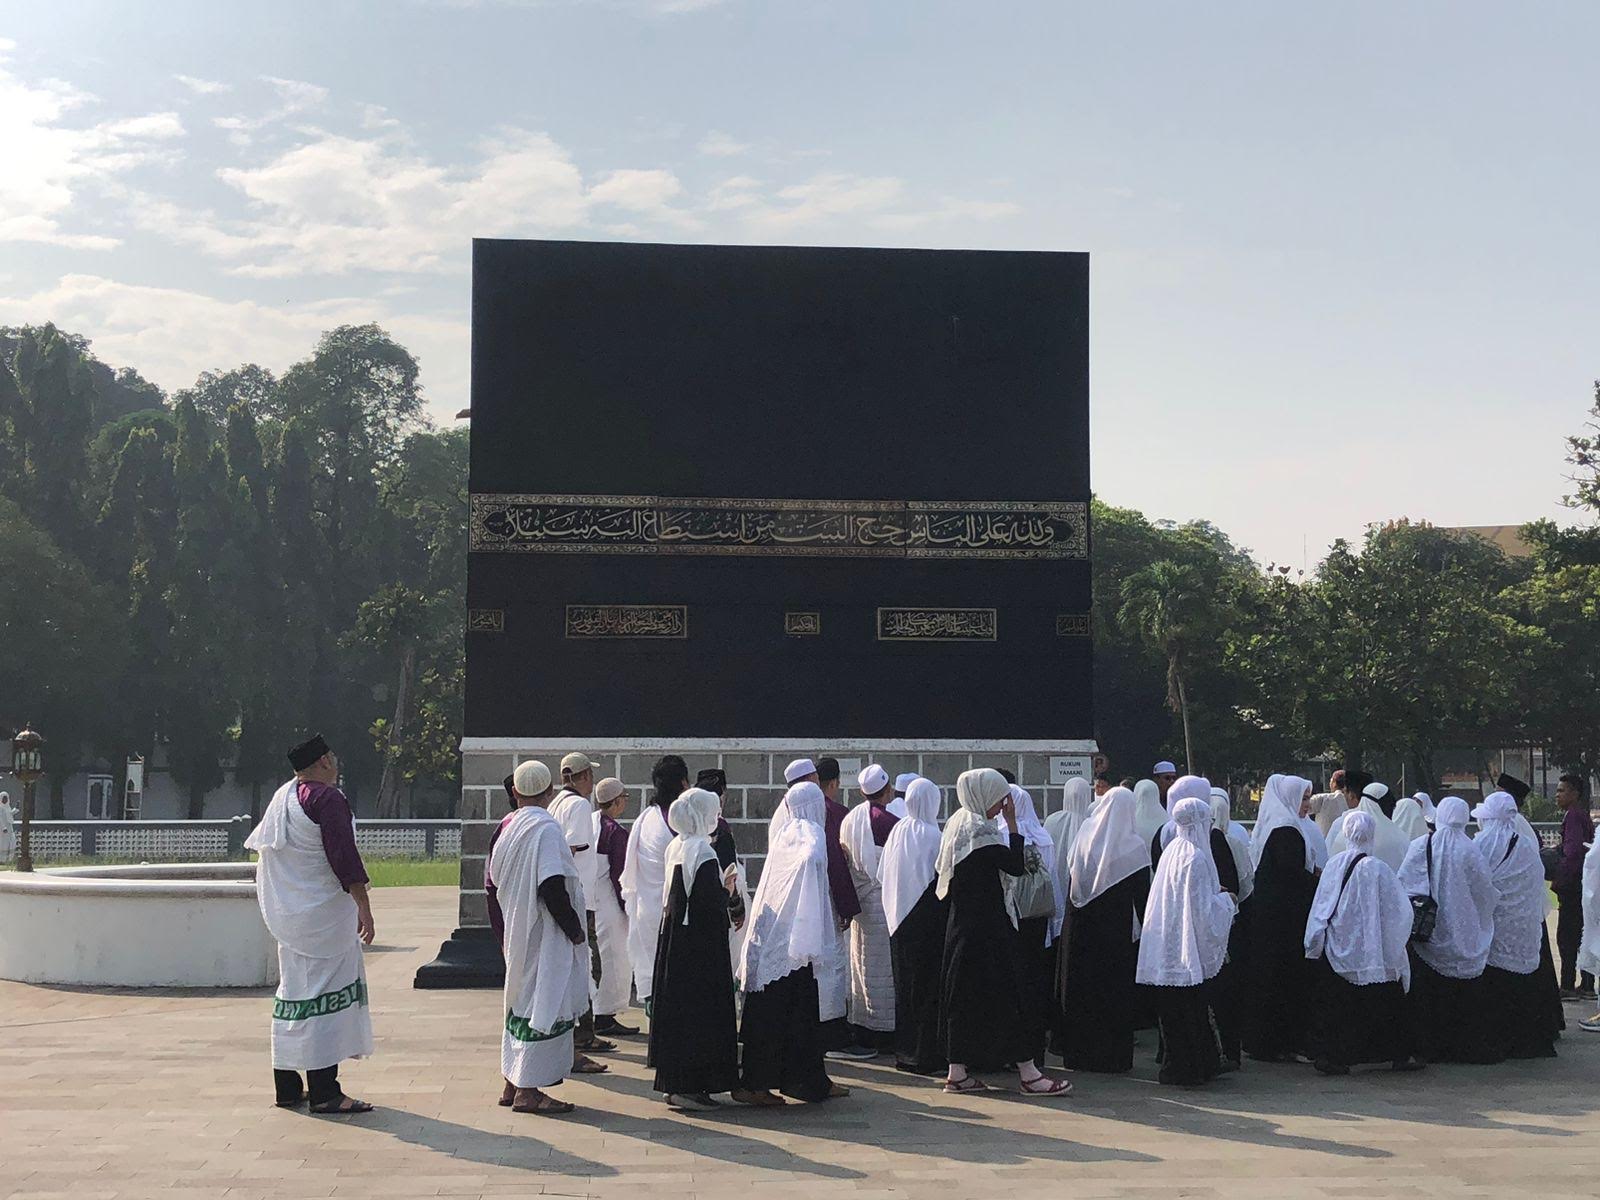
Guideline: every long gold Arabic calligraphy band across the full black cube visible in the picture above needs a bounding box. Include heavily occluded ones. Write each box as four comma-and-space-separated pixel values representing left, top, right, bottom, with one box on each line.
470, 494, 1090, 560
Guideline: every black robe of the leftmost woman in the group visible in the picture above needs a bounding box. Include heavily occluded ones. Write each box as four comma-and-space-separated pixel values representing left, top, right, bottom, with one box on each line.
646, 861, 739, 1094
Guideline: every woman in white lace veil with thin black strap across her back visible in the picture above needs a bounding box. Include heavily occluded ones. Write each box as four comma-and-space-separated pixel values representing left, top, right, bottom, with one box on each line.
1306, 813, 1422, 1075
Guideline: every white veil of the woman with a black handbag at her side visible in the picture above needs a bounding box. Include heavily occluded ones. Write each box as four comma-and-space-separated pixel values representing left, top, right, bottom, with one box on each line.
1400, 795, 1499, 979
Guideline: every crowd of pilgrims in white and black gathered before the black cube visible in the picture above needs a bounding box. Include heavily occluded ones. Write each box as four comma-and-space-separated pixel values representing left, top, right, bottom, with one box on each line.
485, 754, 1592, 1114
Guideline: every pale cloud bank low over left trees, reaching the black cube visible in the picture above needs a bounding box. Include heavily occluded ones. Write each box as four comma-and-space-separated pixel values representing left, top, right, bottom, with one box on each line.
0, 275, 470, 416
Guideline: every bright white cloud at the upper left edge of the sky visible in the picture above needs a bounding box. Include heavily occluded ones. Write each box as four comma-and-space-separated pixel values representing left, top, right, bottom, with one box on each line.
0, 43, 184, 250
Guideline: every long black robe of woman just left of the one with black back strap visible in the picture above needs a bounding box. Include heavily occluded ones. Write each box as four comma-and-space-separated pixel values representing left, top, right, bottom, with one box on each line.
1242, 826, 1317, 1062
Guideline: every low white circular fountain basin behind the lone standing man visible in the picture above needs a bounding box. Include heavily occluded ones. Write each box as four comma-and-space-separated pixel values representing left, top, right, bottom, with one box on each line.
0, 862, 278, 987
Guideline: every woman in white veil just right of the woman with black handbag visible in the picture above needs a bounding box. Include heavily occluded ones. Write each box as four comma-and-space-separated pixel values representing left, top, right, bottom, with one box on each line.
1472, 792, 1557, 1058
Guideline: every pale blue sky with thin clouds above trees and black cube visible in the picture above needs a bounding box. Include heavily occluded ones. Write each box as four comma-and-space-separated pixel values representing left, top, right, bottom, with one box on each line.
0, 0, 1600, 566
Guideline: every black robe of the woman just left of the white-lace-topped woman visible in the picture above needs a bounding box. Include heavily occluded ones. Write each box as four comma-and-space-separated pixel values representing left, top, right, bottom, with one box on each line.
1058, 869, 1150, 1072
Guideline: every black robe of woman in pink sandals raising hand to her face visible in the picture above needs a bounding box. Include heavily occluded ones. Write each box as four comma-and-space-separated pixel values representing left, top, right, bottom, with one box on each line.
939, 834, 1038, 1070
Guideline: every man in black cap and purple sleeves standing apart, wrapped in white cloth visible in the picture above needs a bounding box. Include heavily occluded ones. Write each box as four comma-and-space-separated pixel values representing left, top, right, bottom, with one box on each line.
245, 734, 373, 1114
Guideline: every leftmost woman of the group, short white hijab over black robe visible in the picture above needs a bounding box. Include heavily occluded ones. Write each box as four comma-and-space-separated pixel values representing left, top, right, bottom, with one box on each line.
646, 787, 739, 1112
